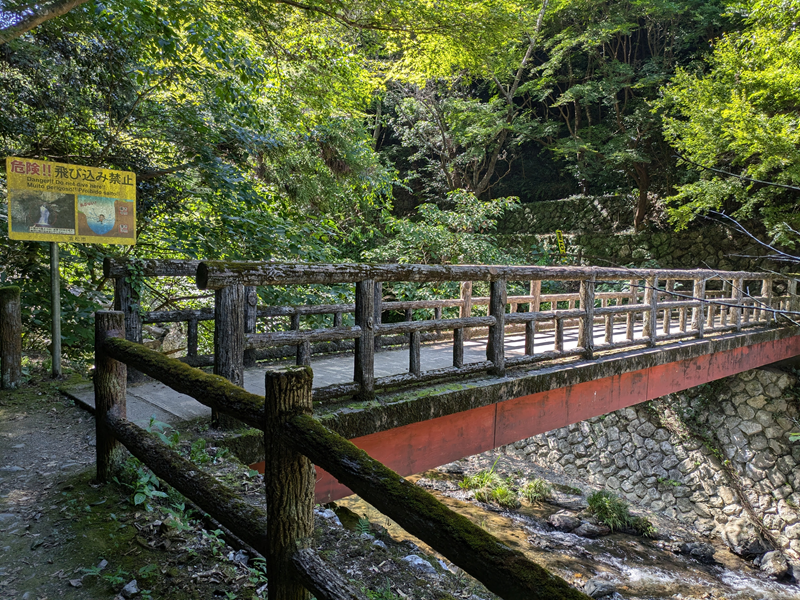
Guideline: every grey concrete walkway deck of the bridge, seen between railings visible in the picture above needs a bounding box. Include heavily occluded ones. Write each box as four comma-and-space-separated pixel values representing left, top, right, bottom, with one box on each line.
62, 324, 641, 425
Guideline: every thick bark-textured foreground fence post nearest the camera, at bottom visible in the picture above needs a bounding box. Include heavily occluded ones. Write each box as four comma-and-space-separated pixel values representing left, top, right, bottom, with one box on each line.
264, 366, 312, 600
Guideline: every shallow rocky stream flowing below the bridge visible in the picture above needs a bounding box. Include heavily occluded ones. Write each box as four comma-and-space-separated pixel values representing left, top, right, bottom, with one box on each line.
337, 468, 800, 600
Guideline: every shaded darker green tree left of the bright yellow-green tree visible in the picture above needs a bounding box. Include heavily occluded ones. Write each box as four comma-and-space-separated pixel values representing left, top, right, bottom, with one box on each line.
523, 0, 725, 229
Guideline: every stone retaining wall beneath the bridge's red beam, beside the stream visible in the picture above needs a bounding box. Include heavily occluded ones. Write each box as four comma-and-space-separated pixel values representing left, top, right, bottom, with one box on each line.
513, 369, 800, 565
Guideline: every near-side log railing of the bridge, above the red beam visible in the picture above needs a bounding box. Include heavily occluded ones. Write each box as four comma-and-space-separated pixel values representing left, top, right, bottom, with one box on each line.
197, 262, 796, 400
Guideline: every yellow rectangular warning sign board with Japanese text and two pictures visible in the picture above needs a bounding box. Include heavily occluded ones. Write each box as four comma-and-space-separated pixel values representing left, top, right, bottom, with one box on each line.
6, 157, 136, 246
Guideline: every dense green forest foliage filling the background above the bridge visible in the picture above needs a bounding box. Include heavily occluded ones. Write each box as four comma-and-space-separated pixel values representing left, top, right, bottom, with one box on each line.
0, 0, 800, 356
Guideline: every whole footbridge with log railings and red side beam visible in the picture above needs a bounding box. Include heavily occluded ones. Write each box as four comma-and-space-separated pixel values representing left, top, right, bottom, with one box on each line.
105, 261, 800, 501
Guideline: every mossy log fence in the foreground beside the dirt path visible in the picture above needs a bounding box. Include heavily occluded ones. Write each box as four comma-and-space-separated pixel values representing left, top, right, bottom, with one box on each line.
95, 310, 588, 600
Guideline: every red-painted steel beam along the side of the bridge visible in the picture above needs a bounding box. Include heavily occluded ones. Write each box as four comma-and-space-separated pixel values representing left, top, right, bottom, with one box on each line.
253, 336, 800, 503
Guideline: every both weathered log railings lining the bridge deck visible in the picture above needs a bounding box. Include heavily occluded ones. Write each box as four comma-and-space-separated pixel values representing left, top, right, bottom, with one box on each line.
105, 261, 798, 401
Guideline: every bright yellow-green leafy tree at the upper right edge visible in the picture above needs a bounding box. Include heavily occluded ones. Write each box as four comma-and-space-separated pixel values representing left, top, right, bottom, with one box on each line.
661, 0, 800, 245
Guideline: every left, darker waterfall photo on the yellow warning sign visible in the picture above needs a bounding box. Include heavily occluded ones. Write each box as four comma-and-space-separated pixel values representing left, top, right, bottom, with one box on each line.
8, 189, 75, 235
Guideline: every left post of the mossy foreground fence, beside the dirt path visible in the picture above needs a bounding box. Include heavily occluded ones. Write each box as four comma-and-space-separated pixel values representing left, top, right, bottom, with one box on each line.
94, 310, 128, 482
